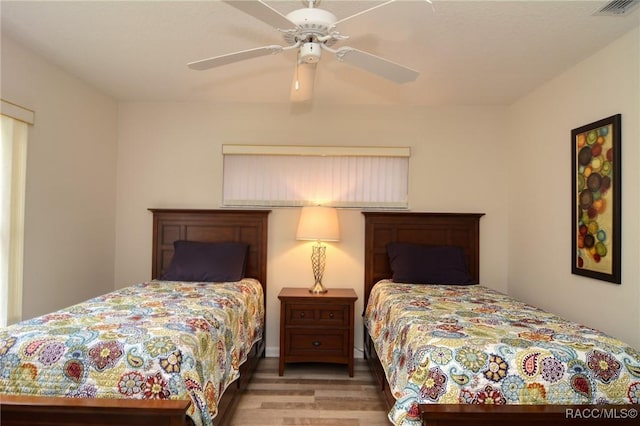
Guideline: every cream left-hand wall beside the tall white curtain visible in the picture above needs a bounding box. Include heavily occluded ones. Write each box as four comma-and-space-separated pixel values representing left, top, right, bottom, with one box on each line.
1, 36, 117, 319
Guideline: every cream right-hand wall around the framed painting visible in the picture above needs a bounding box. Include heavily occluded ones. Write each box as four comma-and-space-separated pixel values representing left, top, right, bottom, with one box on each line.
507, 29, 640, 347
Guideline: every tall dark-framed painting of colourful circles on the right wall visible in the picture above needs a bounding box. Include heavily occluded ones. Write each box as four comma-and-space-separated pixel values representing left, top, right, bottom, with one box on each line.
571, 114, 622, 284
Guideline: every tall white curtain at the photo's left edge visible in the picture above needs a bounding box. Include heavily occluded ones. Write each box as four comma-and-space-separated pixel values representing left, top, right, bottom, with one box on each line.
0, 109, 28, 327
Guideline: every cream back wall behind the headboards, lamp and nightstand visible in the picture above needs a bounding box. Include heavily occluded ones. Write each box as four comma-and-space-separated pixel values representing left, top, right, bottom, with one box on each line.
116, 102, 507, 355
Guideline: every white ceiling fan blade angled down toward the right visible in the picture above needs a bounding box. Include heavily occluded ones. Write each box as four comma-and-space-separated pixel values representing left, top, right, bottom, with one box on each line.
335, 47, 420, 83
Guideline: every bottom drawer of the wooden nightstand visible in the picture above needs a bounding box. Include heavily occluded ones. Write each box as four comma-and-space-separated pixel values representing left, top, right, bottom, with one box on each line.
287, 330, 349, 357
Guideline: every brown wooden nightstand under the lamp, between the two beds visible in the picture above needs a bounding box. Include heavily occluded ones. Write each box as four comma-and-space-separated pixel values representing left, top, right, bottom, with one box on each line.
278, 287, 358, 377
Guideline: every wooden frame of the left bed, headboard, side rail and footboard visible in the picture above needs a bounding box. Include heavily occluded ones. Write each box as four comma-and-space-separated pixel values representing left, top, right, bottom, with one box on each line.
0, 209, 270, 426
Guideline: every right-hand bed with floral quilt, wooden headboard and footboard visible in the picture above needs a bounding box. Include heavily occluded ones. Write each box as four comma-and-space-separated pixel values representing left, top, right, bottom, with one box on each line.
363, 212, 640, 426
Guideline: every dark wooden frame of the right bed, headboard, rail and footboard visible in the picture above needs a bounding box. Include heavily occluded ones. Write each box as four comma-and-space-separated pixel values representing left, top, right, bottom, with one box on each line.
363, 212, 640, 426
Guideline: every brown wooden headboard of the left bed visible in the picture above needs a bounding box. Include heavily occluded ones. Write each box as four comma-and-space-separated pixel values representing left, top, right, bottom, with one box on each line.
149, 209, 270, 294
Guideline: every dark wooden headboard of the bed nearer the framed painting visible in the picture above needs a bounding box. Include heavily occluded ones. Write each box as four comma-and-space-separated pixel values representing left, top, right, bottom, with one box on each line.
362, 212, 484, 306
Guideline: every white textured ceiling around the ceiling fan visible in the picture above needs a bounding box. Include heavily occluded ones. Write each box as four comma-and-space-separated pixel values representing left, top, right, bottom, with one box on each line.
1, 0, 640, 105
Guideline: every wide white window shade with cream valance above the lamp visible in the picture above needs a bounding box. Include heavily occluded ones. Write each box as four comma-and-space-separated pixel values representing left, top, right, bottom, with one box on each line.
223, 145, 410, 208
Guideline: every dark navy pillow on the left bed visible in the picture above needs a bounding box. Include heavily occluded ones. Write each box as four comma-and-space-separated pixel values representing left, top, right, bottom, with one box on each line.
162, 240, 249, 282
